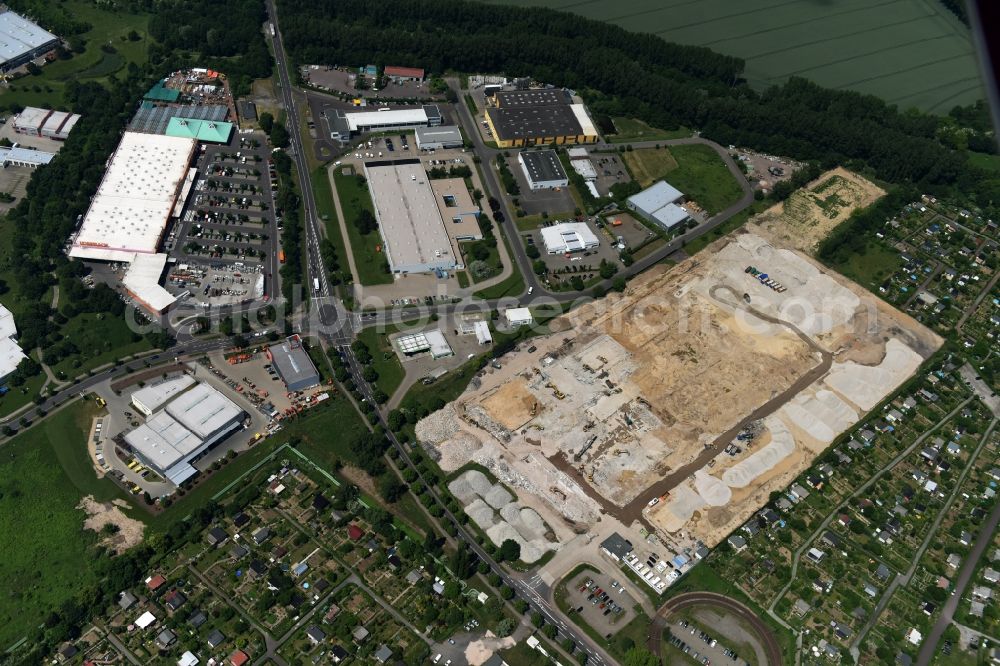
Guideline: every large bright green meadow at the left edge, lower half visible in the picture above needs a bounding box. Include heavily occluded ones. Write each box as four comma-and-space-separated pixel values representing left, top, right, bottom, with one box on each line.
0, 402, 137, 648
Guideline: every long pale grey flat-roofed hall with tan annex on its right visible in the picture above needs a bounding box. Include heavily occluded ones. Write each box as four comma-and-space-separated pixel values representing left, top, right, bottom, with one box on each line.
364, 160, 462, 273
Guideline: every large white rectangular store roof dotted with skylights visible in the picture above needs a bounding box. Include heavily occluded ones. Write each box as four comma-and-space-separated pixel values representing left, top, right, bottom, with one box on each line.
70, 132, 198, 261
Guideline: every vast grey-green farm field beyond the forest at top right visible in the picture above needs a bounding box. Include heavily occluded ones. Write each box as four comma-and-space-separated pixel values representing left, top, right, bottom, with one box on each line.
485, 0, 984, 113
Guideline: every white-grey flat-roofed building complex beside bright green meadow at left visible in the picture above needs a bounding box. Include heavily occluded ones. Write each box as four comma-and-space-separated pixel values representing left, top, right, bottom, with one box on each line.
123, 382, 246, 485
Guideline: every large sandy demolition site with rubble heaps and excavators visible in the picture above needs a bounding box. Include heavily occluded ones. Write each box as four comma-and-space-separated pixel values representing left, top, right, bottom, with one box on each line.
417, 230, 942, 547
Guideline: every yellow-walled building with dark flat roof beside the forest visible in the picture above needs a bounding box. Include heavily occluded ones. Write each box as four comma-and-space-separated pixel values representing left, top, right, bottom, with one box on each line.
486, 88, 600, 148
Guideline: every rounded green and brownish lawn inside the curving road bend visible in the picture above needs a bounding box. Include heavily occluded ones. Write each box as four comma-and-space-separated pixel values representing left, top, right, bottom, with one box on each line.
623, 145, 743, 215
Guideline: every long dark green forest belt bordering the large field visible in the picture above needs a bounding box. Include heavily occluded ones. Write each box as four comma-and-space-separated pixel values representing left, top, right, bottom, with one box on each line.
280, 0, 1000, 213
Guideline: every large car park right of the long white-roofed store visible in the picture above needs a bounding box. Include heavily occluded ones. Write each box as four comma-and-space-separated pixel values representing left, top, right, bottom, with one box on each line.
165, 127, 281, 305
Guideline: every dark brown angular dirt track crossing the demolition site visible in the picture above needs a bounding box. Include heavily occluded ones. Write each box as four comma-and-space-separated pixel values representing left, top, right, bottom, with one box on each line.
549, 285, 833, 532
